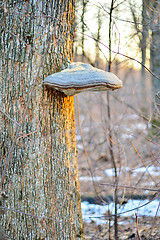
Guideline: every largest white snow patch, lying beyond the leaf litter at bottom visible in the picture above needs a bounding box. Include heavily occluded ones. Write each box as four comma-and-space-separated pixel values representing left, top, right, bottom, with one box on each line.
81, 199, 160, 225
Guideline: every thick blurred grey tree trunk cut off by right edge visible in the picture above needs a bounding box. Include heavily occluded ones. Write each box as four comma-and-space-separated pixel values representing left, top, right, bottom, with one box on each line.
150, 0, 160, 111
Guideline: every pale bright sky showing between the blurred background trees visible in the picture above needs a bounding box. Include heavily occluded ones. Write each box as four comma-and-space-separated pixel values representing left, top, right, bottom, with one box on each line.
76, 0, 145, 68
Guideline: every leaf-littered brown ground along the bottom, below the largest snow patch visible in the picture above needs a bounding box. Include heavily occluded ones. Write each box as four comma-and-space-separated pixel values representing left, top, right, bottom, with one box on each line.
85, 217, 160, 240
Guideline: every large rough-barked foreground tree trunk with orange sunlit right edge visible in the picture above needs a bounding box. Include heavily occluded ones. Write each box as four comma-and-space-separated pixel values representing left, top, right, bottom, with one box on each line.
0, 0, 84, 240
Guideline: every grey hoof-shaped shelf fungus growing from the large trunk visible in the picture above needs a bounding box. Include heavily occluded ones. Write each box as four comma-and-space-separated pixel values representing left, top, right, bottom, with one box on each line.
44, 62, 123, 96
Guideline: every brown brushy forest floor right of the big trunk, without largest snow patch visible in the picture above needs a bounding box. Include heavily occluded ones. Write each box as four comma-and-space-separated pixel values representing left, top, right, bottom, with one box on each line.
75, 66, 160, 240
